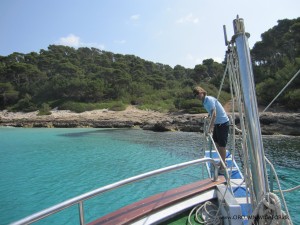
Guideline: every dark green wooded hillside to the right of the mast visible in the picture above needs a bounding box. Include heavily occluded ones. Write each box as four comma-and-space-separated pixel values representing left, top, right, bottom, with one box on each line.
251, 17, 300, 110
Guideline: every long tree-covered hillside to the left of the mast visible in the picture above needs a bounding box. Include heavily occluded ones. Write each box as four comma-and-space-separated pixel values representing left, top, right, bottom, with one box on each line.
0, 45, 224, 111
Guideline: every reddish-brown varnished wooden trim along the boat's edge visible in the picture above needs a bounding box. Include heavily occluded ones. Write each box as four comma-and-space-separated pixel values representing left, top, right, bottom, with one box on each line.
88, 176, 225, 225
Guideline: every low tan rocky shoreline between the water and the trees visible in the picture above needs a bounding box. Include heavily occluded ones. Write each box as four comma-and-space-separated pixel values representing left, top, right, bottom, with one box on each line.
0, 106, 300, 136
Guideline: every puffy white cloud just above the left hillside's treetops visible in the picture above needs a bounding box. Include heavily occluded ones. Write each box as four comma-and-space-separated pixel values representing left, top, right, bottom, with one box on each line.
58, 34, 105, 50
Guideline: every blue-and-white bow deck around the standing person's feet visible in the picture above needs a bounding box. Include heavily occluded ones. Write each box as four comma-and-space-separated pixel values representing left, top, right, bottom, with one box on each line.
205, 151, 252, 225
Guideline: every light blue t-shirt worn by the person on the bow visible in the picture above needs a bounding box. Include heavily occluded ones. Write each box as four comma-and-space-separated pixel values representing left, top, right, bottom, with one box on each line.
203, 96, 229, 124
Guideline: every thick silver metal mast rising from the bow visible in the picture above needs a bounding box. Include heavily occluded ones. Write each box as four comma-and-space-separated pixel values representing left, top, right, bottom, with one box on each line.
233, 17, 269, 203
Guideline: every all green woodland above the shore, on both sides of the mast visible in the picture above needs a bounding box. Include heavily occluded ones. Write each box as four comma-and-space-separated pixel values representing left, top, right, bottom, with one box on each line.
0, 18, 300, 115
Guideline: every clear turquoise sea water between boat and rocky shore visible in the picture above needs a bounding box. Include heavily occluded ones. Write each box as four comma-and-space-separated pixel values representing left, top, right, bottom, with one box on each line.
0, 128, 300, 224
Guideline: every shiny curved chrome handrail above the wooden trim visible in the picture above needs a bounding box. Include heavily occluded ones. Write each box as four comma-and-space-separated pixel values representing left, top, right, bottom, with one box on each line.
11, 158, 218, 225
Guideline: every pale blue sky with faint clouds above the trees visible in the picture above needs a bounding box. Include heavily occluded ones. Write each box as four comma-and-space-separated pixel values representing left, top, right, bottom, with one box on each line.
0, 0, 300, 68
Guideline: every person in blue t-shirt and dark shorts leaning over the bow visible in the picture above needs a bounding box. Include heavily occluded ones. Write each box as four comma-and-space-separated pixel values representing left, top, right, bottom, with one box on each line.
193, 86, 229, 172
